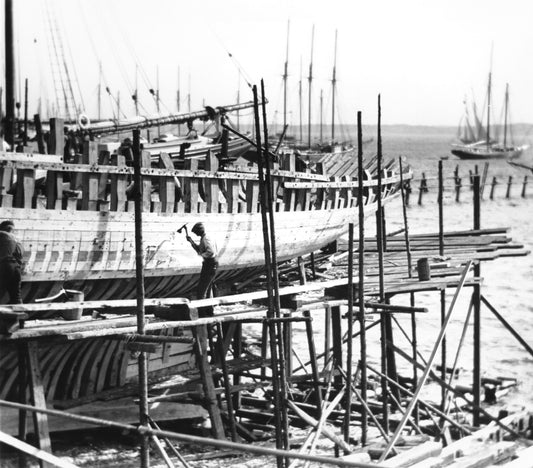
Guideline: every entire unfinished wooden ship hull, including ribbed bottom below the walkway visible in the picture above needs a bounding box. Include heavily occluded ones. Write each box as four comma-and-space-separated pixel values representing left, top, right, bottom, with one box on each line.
0, 122, 408, 424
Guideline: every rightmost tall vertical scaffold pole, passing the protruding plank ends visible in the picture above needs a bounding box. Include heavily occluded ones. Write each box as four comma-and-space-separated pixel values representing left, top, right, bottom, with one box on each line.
472, 175, 481, 426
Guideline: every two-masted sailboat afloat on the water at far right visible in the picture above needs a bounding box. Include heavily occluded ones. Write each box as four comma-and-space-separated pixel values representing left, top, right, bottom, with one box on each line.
451, 73, 528, 159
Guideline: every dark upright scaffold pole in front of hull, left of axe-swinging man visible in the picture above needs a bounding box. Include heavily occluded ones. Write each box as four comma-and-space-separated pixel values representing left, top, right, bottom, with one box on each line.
133, 129, 150, 468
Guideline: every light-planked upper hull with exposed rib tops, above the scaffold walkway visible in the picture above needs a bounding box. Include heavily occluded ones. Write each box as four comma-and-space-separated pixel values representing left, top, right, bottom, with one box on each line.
0, 121, 404, 303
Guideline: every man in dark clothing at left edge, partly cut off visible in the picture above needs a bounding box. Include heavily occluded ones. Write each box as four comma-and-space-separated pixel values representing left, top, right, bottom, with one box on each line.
0, 221, 22, 304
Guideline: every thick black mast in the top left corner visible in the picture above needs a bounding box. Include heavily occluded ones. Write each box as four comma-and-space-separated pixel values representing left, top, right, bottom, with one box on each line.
4, 0, 15, 146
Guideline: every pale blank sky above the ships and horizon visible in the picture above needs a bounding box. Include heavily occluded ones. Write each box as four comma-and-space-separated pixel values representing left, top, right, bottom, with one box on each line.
1, 0, 533, 126
